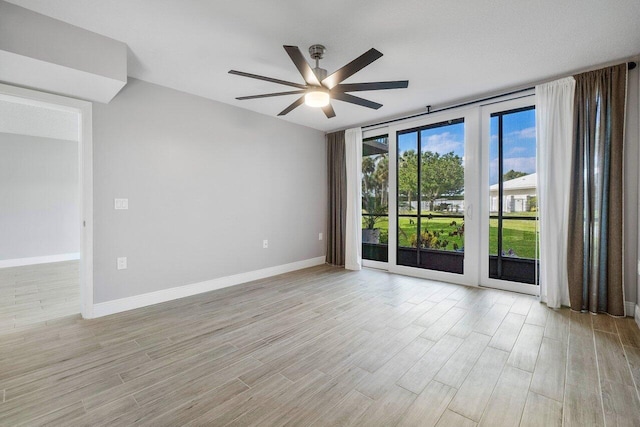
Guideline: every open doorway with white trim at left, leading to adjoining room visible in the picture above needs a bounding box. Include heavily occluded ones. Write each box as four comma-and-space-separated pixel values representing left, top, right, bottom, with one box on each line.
0, 84, 93, 333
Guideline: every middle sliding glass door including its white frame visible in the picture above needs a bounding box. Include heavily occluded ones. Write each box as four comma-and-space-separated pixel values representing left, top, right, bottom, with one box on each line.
388, 109, 480, 285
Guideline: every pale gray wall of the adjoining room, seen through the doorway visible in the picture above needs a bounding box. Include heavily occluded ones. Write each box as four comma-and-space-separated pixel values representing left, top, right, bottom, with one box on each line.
0, 133, 80, 260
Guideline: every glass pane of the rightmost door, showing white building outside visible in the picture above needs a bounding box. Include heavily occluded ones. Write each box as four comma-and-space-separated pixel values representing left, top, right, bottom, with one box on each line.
488, 106, 538, 284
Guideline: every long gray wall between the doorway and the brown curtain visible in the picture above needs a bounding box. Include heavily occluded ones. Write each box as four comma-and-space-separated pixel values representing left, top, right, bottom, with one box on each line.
93, 79, 327, 303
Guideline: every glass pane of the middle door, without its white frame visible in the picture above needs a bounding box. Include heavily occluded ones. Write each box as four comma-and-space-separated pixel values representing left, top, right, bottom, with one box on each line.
396, 119, 465, 274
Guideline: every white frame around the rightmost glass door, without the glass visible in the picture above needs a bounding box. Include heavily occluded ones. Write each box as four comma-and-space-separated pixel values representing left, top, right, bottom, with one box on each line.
479, 92, 540, 295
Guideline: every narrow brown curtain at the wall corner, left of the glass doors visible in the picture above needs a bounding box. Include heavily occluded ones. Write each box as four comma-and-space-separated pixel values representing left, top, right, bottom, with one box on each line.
327, 131, 347, 266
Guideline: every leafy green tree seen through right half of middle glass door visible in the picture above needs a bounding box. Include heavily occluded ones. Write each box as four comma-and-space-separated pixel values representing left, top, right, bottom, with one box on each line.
420, 151, 464, 210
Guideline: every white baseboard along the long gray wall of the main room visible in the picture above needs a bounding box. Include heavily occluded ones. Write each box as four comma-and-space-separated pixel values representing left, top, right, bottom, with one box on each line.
93, 256, 325, 318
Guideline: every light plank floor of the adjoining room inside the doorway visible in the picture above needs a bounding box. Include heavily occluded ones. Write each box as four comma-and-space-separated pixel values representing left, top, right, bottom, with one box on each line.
0, 261, 80, 334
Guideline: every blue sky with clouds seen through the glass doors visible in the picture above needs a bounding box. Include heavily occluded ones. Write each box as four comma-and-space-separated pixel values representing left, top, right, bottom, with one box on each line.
398, 110, 536, 185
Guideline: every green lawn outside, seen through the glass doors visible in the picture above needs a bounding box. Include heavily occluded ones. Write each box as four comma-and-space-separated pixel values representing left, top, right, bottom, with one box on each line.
362, 212, 537, 258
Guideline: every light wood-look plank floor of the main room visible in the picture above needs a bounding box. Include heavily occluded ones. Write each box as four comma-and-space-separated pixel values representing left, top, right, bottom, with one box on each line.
0, 266, 640, 426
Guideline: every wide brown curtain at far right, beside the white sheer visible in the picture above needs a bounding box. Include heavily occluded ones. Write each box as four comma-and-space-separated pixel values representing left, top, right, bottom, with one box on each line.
567, 64, 627, 316
